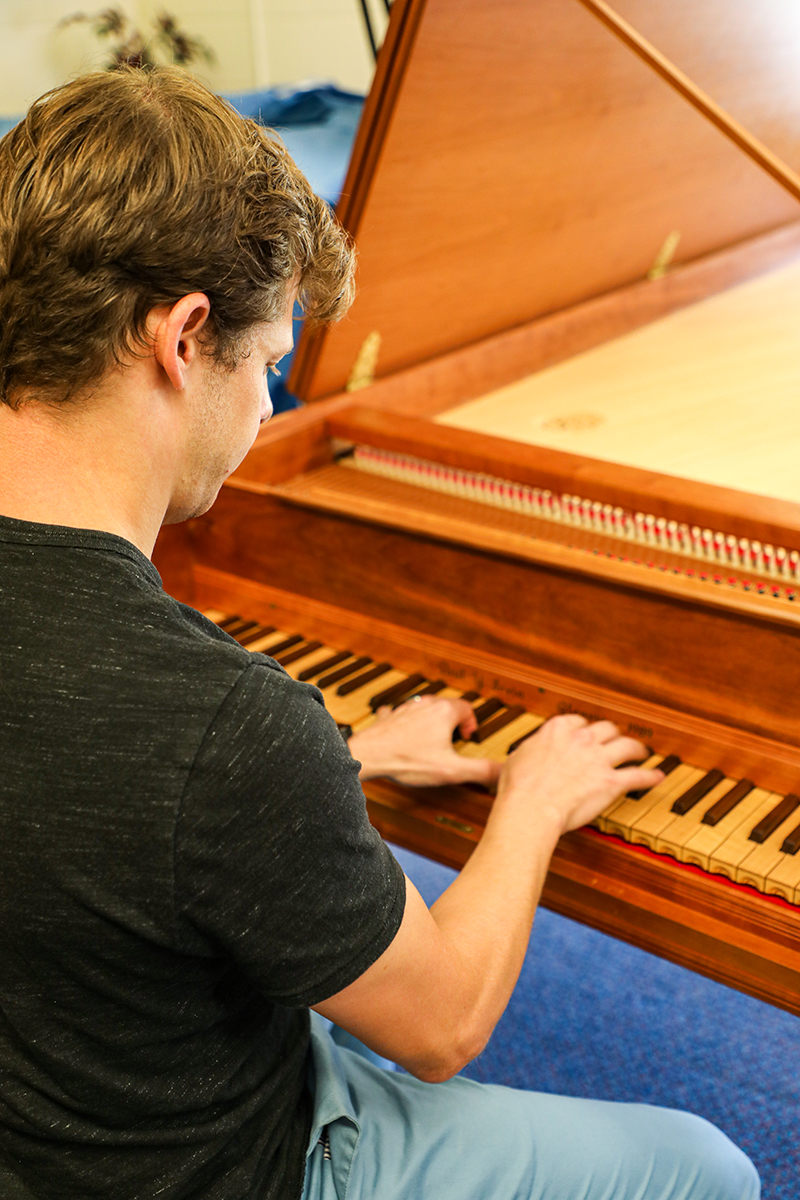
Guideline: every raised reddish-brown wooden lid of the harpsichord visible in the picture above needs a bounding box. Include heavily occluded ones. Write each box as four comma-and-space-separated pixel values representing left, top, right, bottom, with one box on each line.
291, 0, 800, 400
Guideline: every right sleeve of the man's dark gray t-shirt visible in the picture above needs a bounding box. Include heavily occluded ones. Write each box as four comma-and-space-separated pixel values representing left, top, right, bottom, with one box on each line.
175, 656, 405, 1006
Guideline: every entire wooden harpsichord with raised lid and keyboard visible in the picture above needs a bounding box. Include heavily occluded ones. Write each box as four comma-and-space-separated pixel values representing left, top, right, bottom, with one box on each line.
156, 0, 800, 1012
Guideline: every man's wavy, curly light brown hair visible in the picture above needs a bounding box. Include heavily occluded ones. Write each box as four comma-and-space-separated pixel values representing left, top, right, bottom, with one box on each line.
0, 67, 354, 407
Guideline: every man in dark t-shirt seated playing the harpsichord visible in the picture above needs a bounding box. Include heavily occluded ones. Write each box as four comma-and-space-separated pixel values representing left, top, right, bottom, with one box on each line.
0, 63, 758, 1200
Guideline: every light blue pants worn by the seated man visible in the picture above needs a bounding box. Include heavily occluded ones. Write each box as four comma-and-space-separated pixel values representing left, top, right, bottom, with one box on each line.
303, 1013, 760, 1200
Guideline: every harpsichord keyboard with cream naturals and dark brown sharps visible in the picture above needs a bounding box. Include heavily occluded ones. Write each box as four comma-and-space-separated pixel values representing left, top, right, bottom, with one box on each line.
206, 610, 800, 905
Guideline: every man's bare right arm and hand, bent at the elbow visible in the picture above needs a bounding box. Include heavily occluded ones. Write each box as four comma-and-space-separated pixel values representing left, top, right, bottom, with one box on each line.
315, 714, 661, 1081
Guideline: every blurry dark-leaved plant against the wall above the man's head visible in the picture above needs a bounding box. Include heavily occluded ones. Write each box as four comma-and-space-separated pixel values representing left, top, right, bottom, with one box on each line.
56, 8, 213, 71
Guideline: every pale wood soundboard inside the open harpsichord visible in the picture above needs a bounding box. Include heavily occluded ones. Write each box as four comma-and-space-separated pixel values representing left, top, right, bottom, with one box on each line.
438, 263, 800, 502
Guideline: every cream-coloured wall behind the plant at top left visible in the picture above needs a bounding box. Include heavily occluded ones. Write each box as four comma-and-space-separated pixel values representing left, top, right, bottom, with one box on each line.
0, 0, 386, 114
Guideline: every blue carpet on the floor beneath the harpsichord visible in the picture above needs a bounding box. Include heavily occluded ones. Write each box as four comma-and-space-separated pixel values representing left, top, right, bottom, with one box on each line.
392, 847, 800, 1200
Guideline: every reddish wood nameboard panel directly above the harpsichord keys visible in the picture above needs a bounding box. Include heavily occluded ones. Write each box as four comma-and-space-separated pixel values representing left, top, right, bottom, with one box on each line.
164, 472, 800, 744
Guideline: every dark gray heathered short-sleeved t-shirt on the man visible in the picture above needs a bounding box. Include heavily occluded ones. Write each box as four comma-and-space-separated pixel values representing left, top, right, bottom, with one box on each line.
0, 517, 404, 1200
